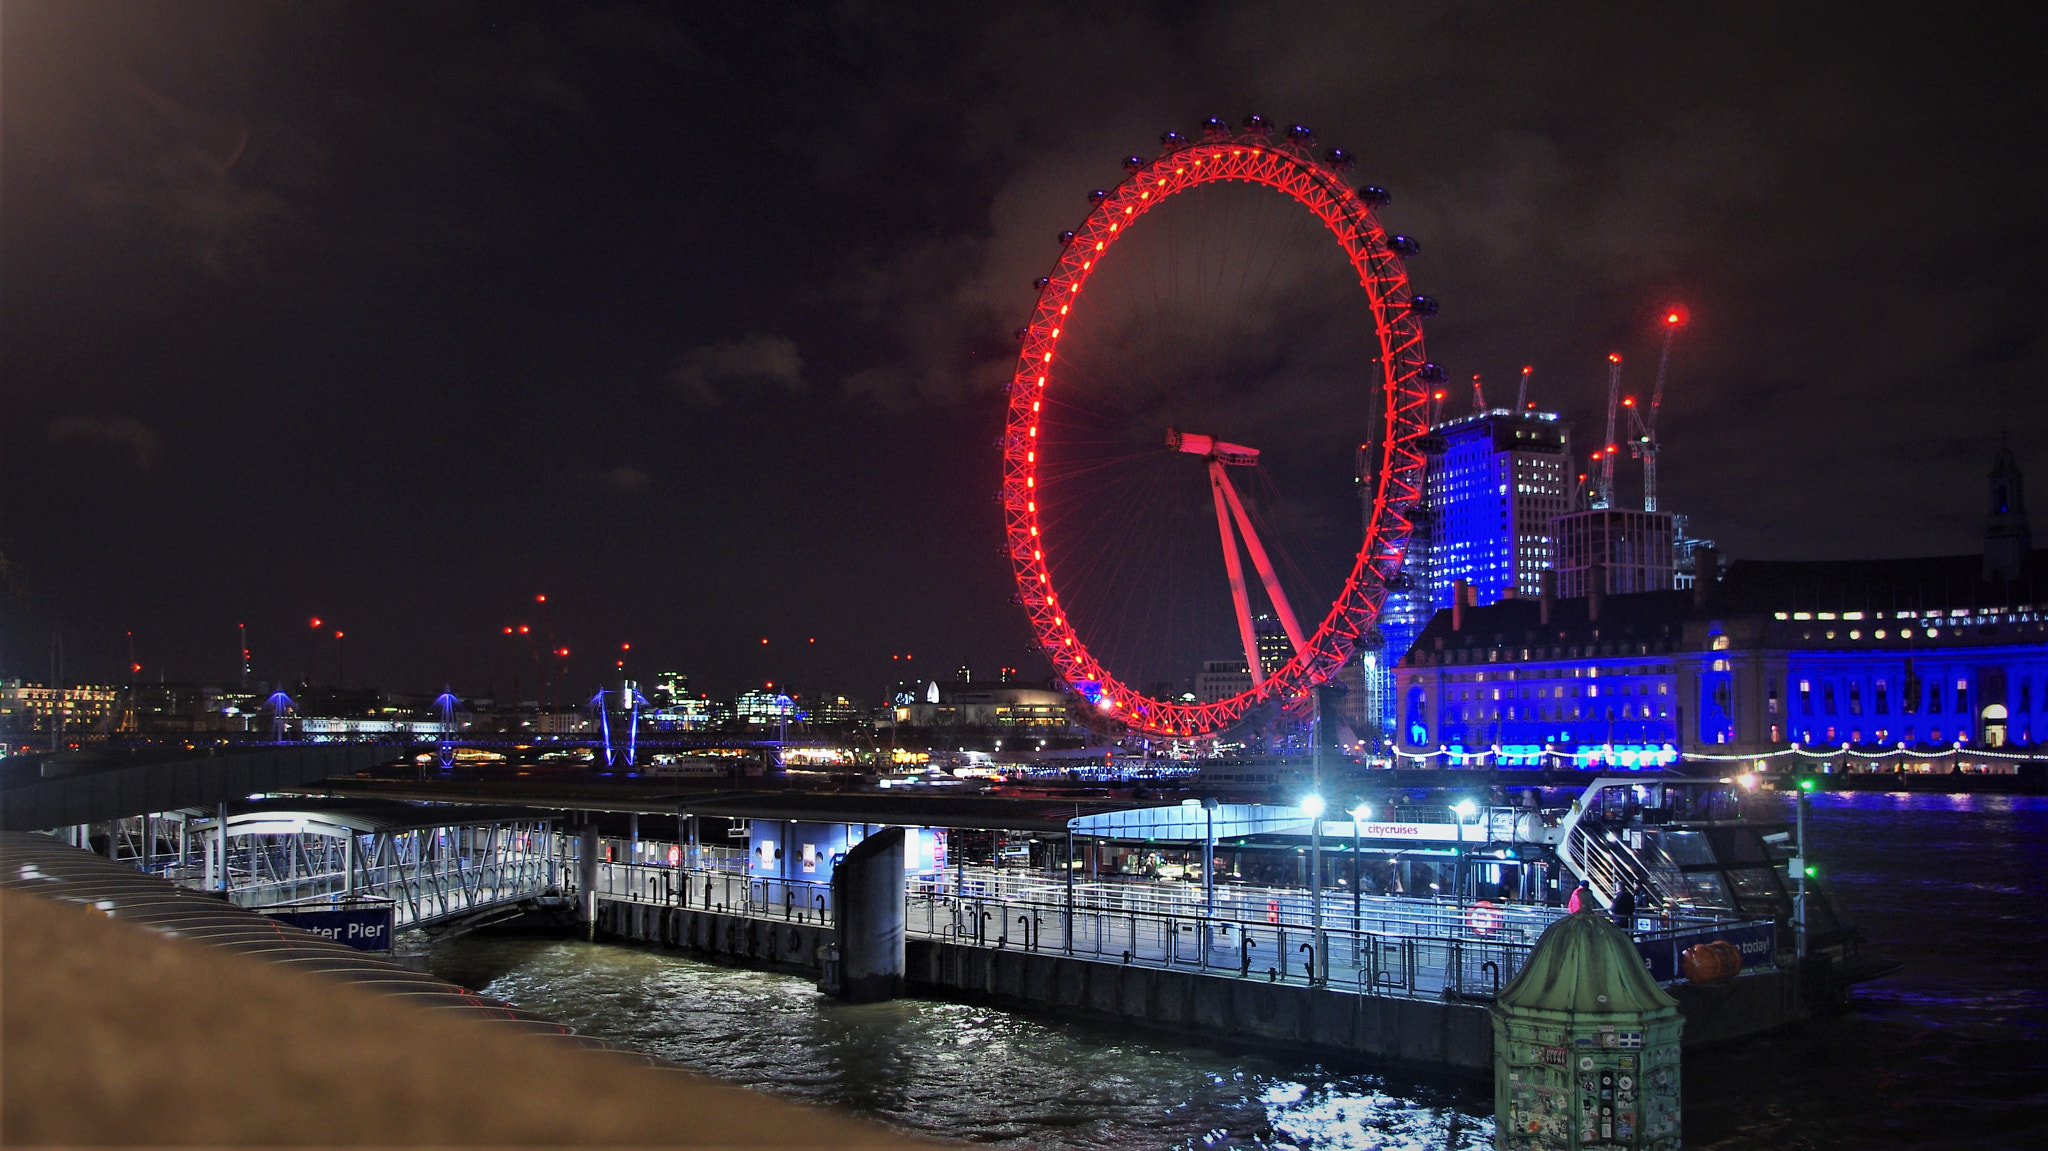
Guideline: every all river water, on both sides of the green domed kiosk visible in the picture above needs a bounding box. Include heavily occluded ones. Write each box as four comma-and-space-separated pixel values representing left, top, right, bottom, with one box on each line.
415, 795, 2048, 1151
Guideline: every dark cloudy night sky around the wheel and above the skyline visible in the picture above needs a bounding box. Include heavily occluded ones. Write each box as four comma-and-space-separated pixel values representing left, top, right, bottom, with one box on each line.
0, 0, 2048, 700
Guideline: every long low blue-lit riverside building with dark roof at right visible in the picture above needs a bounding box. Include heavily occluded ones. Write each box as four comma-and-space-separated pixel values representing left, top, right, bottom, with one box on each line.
1395, 551, 2048, 768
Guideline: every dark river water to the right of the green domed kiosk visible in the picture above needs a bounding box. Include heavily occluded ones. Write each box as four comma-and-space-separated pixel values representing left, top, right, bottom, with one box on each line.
1683, 793, 2048, 1149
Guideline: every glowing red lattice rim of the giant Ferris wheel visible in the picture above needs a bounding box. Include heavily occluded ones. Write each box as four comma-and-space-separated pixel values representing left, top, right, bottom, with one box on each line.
1001, 123, 1434, 737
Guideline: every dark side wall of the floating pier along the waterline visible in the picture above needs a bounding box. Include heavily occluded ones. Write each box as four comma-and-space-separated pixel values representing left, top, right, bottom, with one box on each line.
598, 899, 1806, 1075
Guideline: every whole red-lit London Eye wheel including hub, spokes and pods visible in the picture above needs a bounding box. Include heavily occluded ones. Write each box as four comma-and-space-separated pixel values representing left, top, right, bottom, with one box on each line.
999, 117, 1444, 737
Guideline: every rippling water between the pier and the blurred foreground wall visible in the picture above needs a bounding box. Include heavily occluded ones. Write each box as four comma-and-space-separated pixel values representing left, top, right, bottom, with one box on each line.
430, 938, 1493, 1151
